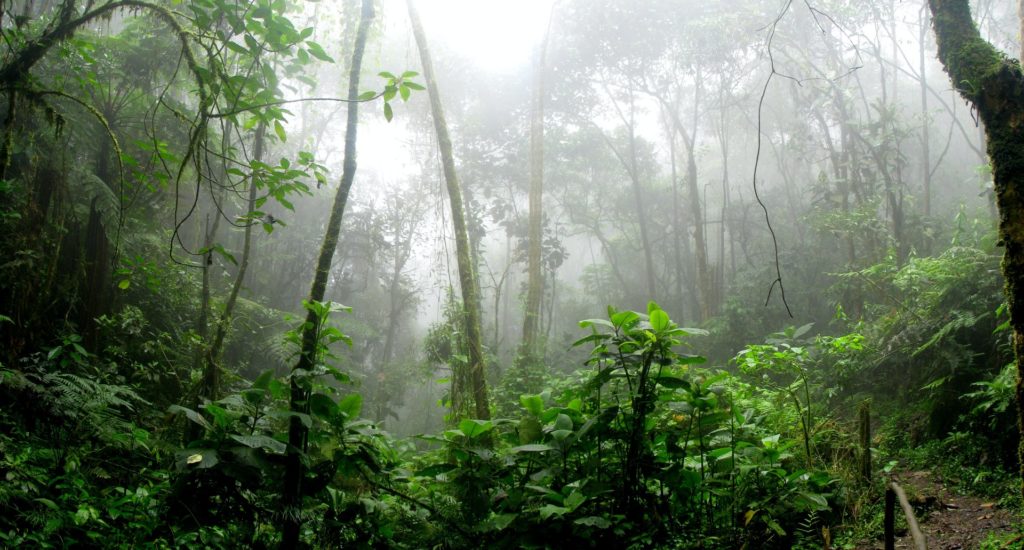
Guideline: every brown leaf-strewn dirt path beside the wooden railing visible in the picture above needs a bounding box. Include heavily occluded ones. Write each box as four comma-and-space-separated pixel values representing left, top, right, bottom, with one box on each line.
857, 471, 1024, 550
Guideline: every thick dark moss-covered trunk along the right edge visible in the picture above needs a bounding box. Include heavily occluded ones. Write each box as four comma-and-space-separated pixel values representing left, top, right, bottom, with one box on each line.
929, 0, 1024, 499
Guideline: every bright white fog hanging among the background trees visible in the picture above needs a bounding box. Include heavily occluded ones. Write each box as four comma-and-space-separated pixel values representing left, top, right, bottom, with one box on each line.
157, 0, 1007, 432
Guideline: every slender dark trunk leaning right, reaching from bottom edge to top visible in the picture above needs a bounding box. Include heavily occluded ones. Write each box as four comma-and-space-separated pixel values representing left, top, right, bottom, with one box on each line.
281, 0, 374, 549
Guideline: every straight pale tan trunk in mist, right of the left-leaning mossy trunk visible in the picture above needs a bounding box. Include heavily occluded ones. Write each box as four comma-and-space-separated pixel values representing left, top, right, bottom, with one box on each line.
522, 7, 554, 363
